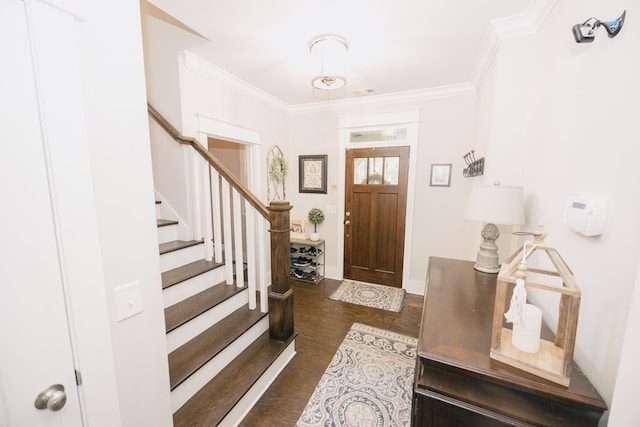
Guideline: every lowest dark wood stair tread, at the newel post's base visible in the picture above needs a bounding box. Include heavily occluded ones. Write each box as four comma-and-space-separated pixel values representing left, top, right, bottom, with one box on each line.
173, 331, 293, 427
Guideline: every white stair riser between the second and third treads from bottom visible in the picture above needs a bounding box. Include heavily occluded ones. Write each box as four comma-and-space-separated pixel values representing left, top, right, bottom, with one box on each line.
167, 285, 249, 353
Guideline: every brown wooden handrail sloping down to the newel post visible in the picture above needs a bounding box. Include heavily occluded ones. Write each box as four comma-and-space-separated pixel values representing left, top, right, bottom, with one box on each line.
147, 104, 271, 222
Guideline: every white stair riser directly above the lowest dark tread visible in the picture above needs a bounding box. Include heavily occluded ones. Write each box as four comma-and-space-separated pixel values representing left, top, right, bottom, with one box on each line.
171, 316, 269, 413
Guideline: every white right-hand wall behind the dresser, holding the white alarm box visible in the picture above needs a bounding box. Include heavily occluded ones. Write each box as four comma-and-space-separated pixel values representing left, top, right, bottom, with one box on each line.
476, 0, 640, 414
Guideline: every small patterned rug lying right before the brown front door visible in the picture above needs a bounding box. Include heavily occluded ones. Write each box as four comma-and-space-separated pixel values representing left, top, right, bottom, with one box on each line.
329, 280, 404, 313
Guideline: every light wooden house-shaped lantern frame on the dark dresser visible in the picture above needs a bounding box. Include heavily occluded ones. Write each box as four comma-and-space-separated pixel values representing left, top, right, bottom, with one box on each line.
491, 226, 580, 387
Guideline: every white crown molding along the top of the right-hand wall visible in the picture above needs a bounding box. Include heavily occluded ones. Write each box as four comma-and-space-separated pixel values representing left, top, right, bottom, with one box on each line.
471, 0, 558, 88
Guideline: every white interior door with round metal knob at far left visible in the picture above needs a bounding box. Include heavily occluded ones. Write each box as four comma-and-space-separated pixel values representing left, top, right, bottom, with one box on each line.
0, 0, 82, 427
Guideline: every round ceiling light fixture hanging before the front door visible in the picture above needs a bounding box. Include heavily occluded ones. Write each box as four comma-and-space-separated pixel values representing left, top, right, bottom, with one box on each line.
309, 34, 349, 90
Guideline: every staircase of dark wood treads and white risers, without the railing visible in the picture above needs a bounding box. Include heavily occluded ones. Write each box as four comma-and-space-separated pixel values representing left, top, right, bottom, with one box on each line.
157, 203, 295, 427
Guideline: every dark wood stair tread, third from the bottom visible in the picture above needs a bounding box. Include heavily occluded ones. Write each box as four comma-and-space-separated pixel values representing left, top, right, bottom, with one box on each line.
164, 282, 247, 333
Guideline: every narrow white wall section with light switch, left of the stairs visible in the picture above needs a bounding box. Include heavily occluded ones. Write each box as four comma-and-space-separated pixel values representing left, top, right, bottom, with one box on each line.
77, 0, 172, 427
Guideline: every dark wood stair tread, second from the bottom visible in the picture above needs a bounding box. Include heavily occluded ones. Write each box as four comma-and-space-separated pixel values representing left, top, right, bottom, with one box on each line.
169, 305, 267, 390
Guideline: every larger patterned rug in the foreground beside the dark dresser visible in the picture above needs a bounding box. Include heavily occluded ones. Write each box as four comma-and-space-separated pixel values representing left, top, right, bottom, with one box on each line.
296, 323, 417, 427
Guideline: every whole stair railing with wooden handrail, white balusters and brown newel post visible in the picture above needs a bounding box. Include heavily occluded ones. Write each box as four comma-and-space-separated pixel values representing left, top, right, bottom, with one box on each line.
147, 104, 294, 341
